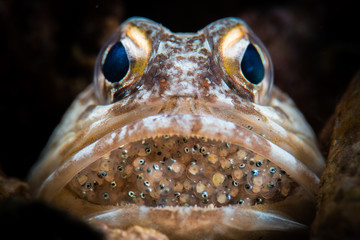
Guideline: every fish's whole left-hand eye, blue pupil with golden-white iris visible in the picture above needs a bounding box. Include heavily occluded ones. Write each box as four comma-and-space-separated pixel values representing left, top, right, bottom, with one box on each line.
94, 20, 152, 104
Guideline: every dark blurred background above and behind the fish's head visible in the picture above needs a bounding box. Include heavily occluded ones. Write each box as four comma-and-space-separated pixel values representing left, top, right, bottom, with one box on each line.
0, 0, 360, 179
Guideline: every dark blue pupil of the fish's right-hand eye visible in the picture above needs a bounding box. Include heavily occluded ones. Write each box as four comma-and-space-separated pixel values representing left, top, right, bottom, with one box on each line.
241, 43, 265, 84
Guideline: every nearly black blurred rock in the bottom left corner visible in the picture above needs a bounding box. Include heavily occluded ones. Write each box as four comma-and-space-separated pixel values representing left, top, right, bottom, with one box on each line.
0, 197, 103, 240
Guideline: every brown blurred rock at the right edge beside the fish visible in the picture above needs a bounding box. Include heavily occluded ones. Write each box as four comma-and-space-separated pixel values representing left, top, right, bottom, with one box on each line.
311, 72, 360, 240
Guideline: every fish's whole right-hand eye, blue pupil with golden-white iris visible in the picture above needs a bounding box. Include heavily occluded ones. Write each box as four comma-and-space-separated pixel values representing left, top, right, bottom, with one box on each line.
217, 18, 274, 105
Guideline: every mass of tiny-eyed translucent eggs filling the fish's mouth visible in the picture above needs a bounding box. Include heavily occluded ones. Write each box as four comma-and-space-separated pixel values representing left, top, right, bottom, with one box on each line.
68, 136, 295, 207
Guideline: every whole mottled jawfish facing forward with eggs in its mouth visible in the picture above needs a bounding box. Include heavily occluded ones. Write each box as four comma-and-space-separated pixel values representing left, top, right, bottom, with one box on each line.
29, 18, 325, 239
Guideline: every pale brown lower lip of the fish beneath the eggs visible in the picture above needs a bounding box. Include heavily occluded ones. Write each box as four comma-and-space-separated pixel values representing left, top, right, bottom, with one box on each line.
87, 206, 308, 236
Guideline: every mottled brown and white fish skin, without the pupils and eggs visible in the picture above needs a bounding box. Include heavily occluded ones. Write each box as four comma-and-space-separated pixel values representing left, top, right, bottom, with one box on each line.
29, 18, 325, 239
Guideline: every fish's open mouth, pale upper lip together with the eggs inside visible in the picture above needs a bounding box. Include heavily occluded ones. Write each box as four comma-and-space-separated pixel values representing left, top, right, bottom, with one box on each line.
35, 114, 319, 234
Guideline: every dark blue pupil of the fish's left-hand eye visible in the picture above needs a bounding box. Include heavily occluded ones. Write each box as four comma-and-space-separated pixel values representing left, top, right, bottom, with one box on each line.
102, 41, 129, 83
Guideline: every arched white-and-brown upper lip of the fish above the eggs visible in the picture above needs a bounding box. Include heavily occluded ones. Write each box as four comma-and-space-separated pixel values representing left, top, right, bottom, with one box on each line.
38, 114, 320, 201
